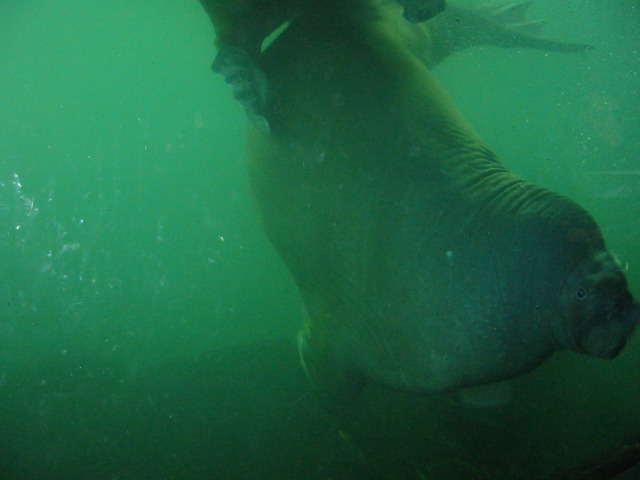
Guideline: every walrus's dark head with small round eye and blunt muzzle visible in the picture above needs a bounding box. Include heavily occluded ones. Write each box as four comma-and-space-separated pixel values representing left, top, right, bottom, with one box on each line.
560, 251, 640, 358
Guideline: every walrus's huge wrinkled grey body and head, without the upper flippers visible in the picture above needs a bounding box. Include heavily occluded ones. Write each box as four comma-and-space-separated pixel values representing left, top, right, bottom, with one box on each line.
198, 0, 640, 395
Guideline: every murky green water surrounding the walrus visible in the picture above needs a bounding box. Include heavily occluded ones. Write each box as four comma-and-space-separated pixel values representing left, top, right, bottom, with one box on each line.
0, 0, 640, 480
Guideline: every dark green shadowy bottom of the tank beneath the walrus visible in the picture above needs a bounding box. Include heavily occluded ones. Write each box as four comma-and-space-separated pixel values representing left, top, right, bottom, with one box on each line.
0, 342, 640, 480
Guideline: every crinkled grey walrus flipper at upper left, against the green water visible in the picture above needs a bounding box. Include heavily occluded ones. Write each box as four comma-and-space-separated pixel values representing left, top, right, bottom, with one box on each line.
211, 45, 270, 133
